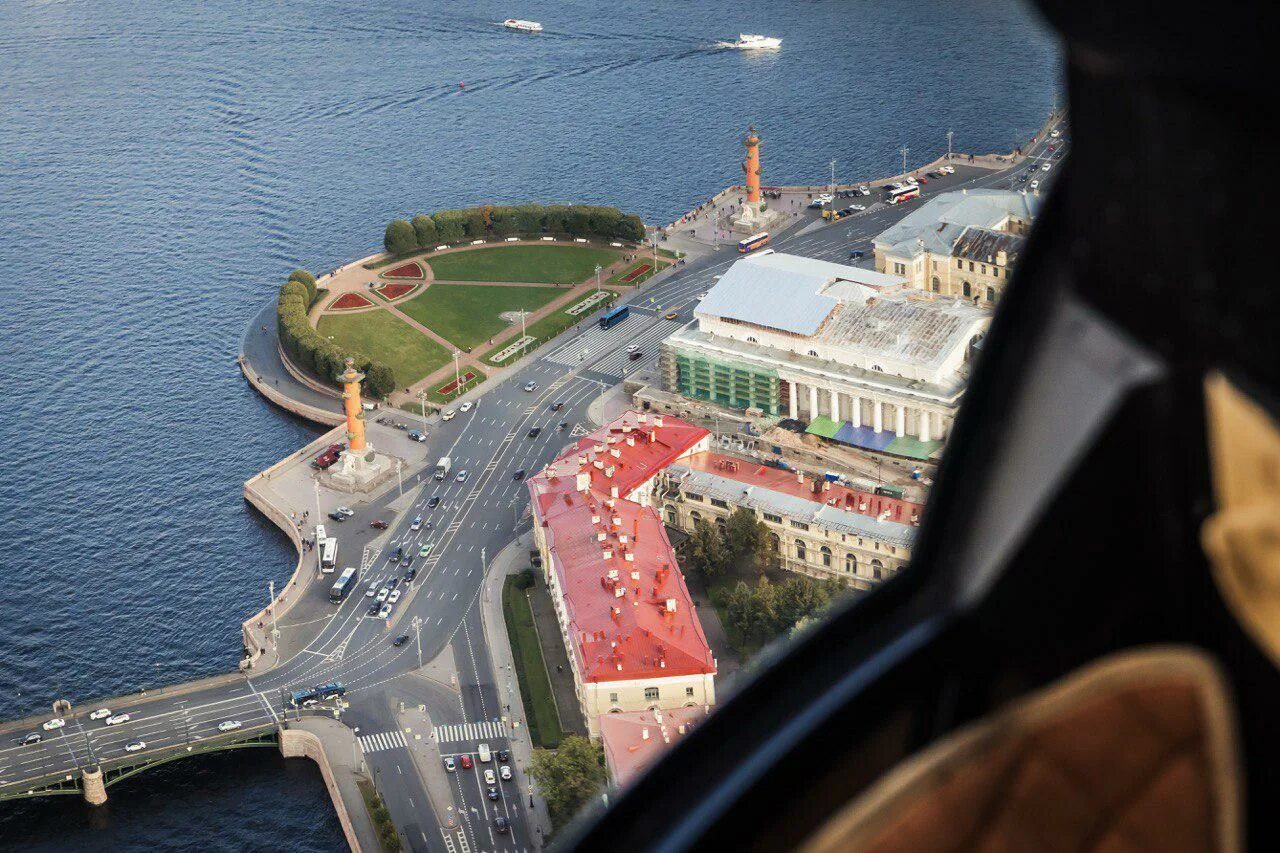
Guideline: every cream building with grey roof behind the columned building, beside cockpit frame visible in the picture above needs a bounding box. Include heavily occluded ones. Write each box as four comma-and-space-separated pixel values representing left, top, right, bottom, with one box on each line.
874, 190, 1039, 306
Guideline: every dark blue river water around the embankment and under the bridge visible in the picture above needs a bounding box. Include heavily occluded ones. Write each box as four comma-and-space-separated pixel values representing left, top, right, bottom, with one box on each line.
0, 0, 1057, 849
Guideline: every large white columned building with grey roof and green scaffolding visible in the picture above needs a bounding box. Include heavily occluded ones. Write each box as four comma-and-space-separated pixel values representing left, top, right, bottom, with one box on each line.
662, 254, 989, 459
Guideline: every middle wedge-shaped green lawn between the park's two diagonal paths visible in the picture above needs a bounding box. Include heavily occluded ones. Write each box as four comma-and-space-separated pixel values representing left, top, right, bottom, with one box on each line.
399, 283, 564, 350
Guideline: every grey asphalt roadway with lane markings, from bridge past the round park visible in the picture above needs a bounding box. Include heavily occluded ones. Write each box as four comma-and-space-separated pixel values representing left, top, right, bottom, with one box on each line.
0, 114, 1066, 853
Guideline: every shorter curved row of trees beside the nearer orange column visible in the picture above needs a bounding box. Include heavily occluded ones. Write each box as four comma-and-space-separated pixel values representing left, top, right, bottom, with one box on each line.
275, 269, 396, 397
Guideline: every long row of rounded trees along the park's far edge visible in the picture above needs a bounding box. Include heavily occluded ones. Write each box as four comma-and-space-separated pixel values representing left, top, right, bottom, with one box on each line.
383, 205, 644, 255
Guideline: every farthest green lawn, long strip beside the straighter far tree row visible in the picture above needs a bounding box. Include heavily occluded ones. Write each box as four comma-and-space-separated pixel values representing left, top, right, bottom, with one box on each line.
429, 243, 622, 284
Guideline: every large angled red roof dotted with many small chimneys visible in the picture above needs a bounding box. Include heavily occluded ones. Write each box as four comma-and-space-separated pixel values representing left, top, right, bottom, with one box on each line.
529, 412, 716, 681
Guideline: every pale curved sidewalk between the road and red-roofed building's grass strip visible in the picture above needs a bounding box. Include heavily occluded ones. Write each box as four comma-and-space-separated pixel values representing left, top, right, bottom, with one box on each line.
480, 533, 552, 849
